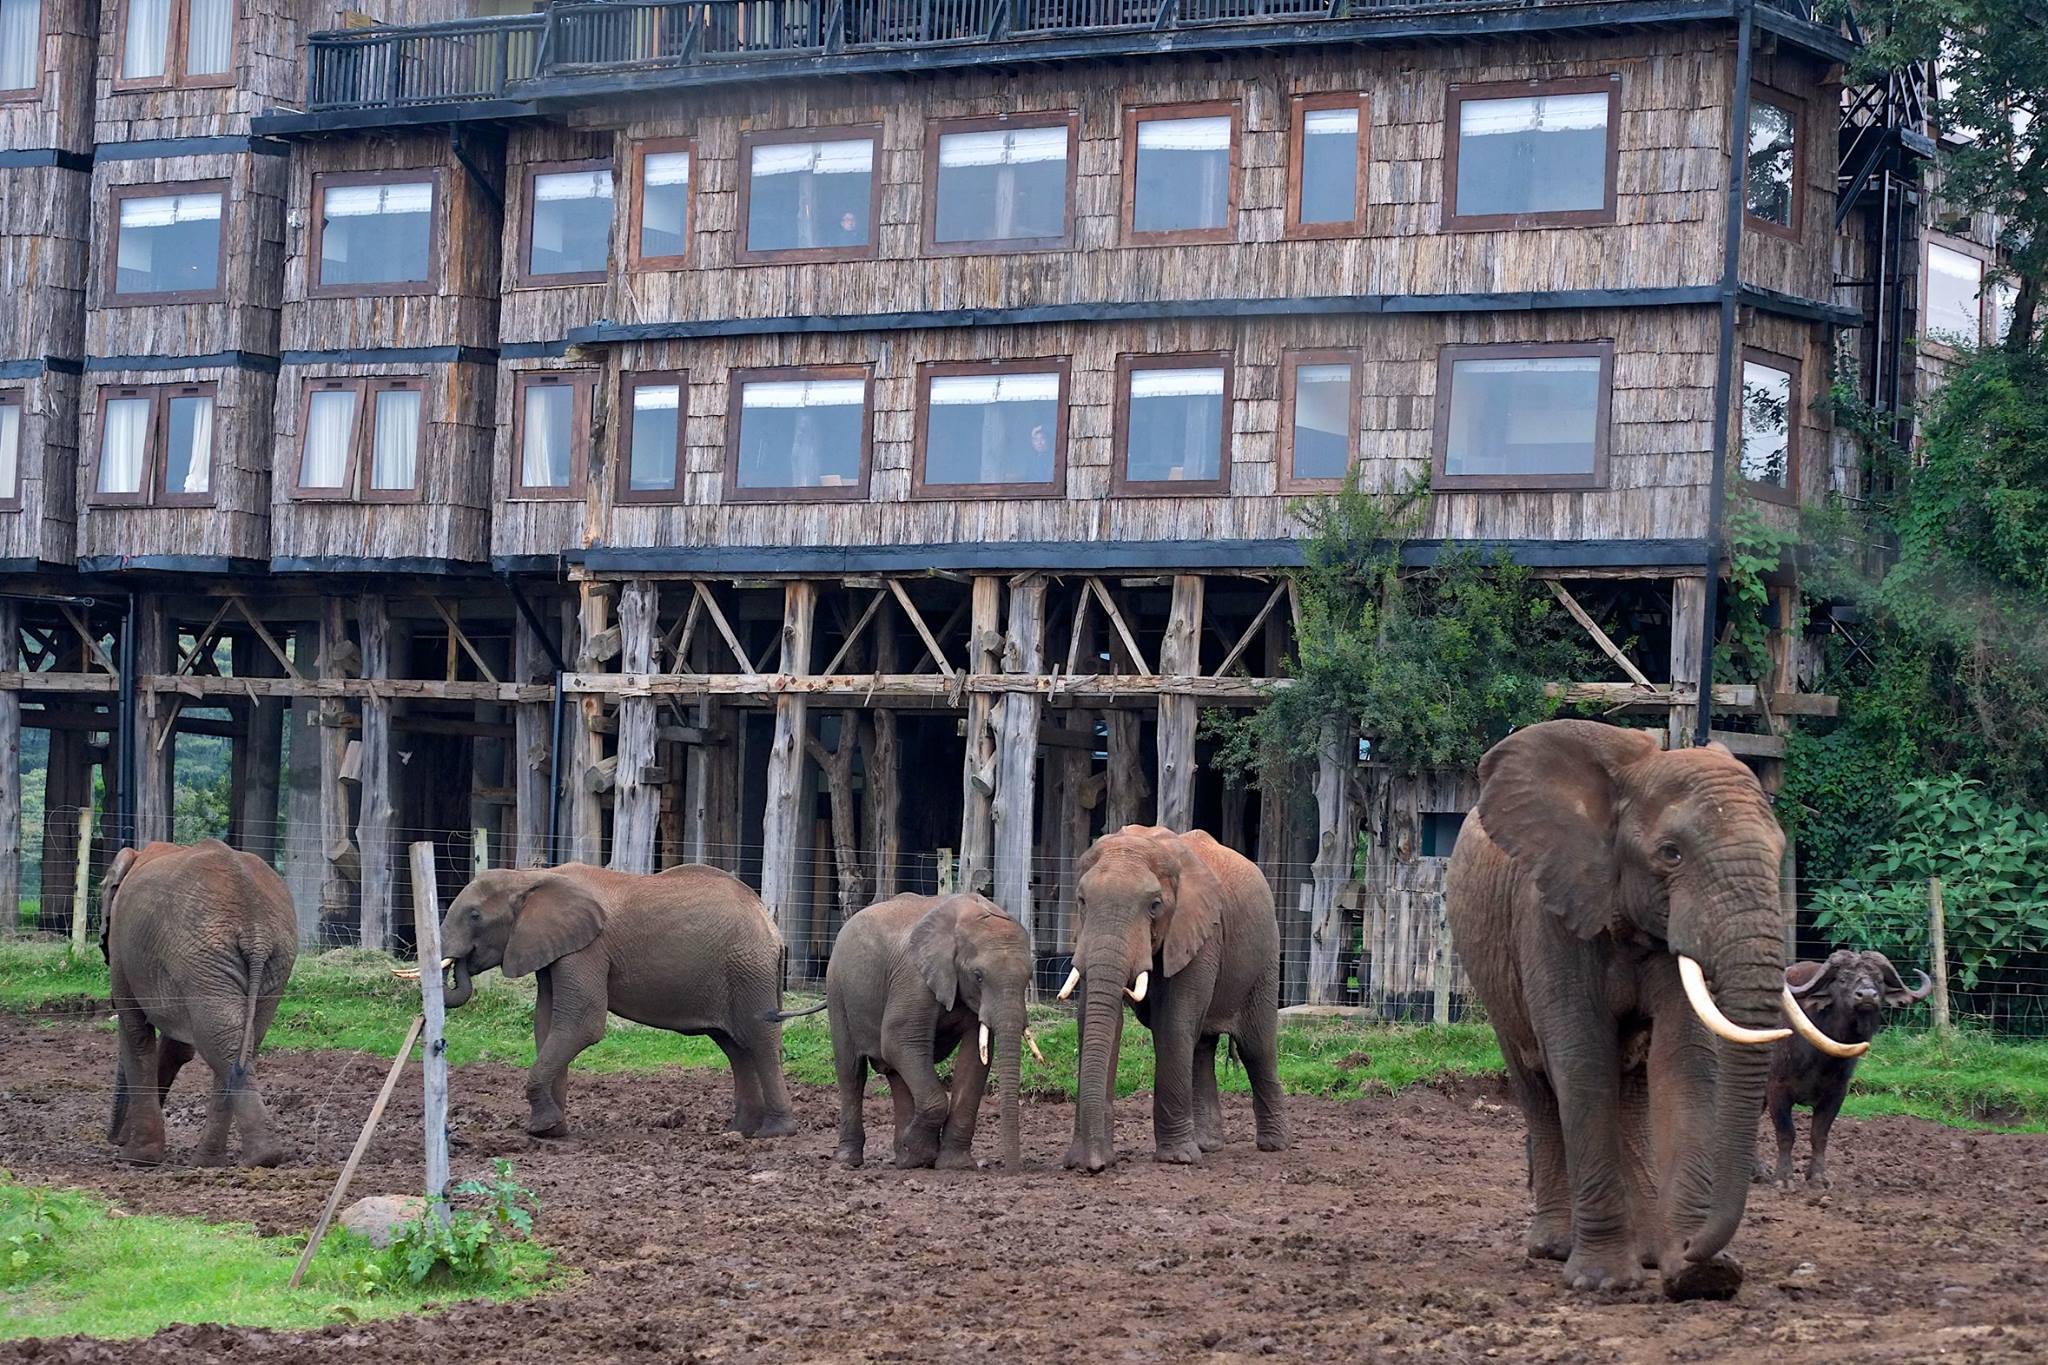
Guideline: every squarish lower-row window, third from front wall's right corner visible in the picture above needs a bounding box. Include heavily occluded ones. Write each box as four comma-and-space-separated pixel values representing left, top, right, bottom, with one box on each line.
1114, 352, 1231, 493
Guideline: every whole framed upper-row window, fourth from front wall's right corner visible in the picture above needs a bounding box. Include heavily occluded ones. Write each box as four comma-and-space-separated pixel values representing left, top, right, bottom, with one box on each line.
924, 115, 1077, 252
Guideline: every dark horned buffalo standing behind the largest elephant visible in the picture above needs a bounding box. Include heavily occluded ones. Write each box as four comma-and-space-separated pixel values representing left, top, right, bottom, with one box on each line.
1757, 950, 1933, 1187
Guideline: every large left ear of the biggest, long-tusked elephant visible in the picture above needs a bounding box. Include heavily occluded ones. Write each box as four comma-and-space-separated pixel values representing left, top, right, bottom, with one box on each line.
1479, 720, 1659, 939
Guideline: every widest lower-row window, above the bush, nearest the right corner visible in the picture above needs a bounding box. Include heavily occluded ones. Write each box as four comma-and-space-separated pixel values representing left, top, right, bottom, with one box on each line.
1436, 342, 1614, 489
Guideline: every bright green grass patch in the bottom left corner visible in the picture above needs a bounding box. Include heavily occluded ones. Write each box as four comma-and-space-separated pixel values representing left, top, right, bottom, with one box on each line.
0, 1173, 549, 1340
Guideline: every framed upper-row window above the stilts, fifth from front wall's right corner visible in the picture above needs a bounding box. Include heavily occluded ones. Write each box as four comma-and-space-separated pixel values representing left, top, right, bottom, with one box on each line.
737, 127, 881, 260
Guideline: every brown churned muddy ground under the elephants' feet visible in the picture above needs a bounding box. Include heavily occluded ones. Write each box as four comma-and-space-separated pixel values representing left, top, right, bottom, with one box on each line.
0, 1017, 2048, 1365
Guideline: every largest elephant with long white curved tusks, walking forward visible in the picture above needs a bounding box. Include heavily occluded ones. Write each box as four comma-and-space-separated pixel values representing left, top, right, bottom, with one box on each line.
1444, 720, 1839, 1297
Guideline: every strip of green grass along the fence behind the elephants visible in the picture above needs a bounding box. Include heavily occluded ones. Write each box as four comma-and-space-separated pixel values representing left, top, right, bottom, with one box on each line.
0, 941, 2048, 1132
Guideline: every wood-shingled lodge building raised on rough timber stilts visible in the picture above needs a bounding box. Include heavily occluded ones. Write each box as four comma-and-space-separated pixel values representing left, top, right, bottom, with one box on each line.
0, 0, 1957, 1001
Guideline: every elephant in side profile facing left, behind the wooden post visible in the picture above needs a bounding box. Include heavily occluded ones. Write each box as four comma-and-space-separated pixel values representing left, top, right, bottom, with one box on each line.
440, 864, 797, 1138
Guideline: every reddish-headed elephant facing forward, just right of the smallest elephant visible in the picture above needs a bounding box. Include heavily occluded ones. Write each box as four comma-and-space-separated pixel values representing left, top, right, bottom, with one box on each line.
1061, 825, 1288, 1173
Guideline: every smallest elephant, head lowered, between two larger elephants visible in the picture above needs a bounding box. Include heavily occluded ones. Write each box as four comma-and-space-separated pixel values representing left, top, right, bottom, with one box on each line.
825, 894, 1032, 1171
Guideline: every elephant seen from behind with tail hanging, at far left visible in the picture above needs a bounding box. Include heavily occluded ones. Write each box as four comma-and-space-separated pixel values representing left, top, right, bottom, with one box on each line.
100, 839, 299, 1166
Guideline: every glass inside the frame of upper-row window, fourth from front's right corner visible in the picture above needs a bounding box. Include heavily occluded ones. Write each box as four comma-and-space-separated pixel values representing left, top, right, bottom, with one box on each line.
934, 127, 1067, 241
